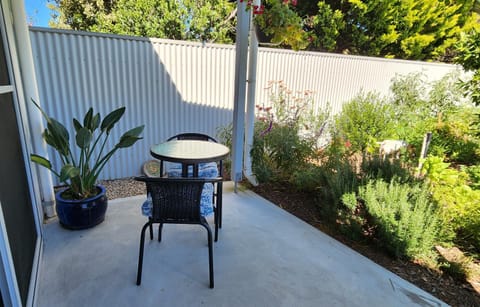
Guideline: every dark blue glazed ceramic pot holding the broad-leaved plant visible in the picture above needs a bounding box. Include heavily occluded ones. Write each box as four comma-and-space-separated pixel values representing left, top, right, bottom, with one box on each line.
55, 185, 108, 229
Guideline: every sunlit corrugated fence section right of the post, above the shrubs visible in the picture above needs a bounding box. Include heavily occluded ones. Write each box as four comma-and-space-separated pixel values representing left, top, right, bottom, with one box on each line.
256, 48, 456, 113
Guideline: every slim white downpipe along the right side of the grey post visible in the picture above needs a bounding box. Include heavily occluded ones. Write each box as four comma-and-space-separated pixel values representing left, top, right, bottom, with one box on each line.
244, 12, 260, 186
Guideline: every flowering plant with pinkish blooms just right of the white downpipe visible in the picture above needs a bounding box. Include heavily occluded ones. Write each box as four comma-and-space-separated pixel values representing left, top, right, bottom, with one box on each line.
250, 81, 328, 182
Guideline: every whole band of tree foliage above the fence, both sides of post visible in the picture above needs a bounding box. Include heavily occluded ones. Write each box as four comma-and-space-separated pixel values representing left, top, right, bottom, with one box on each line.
50, 0, 480, 61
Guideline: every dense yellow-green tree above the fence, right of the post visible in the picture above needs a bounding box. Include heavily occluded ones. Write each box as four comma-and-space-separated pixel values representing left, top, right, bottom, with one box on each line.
297, 0, 478, 60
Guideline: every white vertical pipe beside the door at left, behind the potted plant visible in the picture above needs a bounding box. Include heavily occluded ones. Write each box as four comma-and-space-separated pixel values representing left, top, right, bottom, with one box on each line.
12, 2, 55, 215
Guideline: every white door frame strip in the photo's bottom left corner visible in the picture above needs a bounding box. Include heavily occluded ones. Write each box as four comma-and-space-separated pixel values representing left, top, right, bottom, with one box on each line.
0, 203, 22, 307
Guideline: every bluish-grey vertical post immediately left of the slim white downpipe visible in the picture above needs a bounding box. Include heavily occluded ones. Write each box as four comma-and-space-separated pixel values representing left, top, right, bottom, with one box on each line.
231, 0, 250, 192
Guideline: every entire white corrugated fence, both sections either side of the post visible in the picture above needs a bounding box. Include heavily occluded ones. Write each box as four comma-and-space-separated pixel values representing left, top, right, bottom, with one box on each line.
30, 28, 455, 179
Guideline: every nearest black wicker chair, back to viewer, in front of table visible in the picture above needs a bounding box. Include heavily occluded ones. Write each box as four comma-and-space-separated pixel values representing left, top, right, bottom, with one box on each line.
135, 177, 221, 288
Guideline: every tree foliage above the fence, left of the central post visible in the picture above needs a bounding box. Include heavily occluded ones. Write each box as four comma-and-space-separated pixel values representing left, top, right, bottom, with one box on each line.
51, 0, 235, 43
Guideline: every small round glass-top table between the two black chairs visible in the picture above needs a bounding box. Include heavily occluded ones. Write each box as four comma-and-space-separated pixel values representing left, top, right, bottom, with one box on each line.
150, 140, 230, 177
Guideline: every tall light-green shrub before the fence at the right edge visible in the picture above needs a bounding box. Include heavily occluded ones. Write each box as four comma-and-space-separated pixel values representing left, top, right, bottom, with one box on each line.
391, 72, 480, 164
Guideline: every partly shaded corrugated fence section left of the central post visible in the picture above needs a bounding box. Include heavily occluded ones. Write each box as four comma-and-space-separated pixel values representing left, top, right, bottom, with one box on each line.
30, 28, 235, 179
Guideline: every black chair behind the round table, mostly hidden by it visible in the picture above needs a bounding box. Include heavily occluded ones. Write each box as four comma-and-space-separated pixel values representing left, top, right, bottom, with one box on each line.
160, 132, 223, 242
